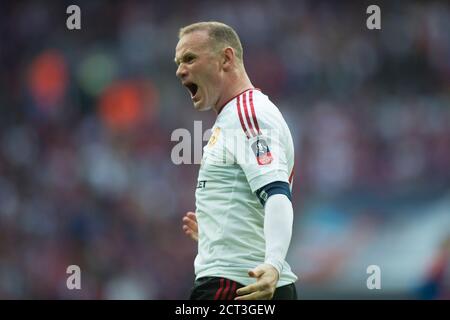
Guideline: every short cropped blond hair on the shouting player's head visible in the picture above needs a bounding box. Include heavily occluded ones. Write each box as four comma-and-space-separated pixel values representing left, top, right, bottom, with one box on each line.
178, 21, 244, 63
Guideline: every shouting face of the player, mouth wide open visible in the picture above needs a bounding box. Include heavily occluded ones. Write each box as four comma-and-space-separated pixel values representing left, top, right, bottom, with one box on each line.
175, 31, 222, 111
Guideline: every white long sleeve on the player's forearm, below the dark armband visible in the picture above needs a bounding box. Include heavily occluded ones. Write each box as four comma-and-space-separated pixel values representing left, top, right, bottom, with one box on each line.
264, 194, 294, 274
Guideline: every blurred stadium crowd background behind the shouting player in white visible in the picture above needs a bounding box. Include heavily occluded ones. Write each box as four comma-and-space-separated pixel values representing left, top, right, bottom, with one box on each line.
0, 0, 450, 299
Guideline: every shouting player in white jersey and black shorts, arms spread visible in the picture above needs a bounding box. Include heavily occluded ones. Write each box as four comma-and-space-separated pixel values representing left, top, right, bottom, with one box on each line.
175, 22, 297, 300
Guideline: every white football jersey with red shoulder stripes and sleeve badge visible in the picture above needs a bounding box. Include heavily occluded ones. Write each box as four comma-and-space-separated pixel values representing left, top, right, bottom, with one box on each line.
194, 89, 297, 287
